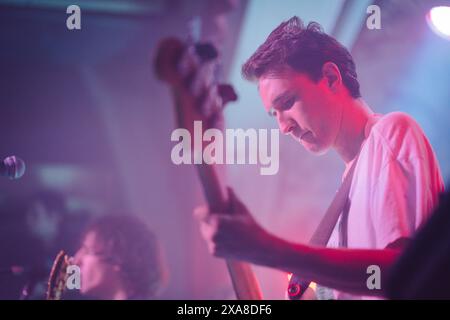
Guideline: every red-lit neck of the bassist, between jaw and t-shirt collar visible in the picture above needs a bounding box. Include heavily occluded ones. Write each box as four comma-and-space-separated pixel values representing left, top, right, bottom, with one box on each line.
334, 99, 373, 164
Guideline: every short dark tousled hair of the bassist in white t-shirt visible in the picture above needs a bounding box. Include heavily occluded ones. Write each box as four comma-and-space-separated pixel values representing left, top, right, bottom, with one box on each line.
242, 16, 361, 98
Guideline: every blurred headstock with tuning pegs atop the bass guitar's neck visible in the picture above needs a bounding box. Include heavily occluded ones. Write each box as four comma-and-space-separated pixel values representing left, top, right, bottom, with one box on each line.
154, 38, 237, 130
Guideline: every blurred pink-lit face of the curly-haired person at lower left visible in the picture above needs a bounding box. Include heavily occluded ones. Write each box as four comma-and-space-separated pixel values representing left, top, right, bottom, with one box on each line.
74, 232, 118, 298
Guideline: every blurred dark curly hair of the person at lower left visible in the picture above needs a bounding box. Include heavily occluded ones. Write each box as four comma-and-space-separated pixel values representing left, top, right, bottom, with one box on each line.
84, 215, 167, 299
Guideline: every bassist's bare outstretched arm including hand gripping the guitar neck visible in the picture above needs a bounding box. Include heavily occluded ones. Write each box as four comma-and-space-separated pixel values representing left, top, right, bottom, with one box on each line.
196, 190, 406, 296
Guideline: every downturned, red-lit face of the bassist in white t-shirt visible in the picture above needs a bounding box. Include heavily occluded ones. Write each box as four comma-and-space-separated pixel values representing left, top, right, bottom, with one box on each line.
258, 71, 342, 154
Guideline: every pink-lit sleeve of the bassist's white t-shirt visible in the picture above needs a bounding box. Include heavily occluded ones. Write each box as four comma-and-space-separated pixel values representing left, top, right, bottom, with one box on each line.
371, 114, 443, 248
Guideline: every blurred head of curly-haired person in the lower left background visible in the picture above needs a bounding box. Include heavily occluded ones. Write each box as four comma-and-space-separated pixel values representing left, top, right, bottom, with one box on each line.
72, 215, 166, 300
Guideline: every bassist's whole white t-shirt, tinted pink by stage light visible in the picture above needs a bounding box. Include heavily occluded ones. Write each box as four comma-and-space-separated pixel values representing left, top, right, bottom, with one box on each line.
320, 112, 444, 299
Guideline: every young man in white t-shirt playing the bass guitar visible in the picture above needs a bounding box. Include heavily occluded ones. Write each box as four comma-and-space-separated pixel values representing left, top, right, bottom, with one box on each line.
196, 17, 444, 299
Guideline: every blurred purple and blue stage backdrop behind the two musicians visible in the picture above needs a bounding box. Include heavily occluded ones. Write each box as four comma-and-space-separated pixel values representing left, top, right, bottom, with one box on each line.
0, 0, 450, 299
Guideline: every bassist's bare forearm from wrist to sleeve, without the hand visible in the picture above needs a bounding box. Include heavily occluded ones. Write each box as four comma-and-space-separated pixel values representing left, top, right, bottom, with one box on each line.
254, 235, 406, 296
